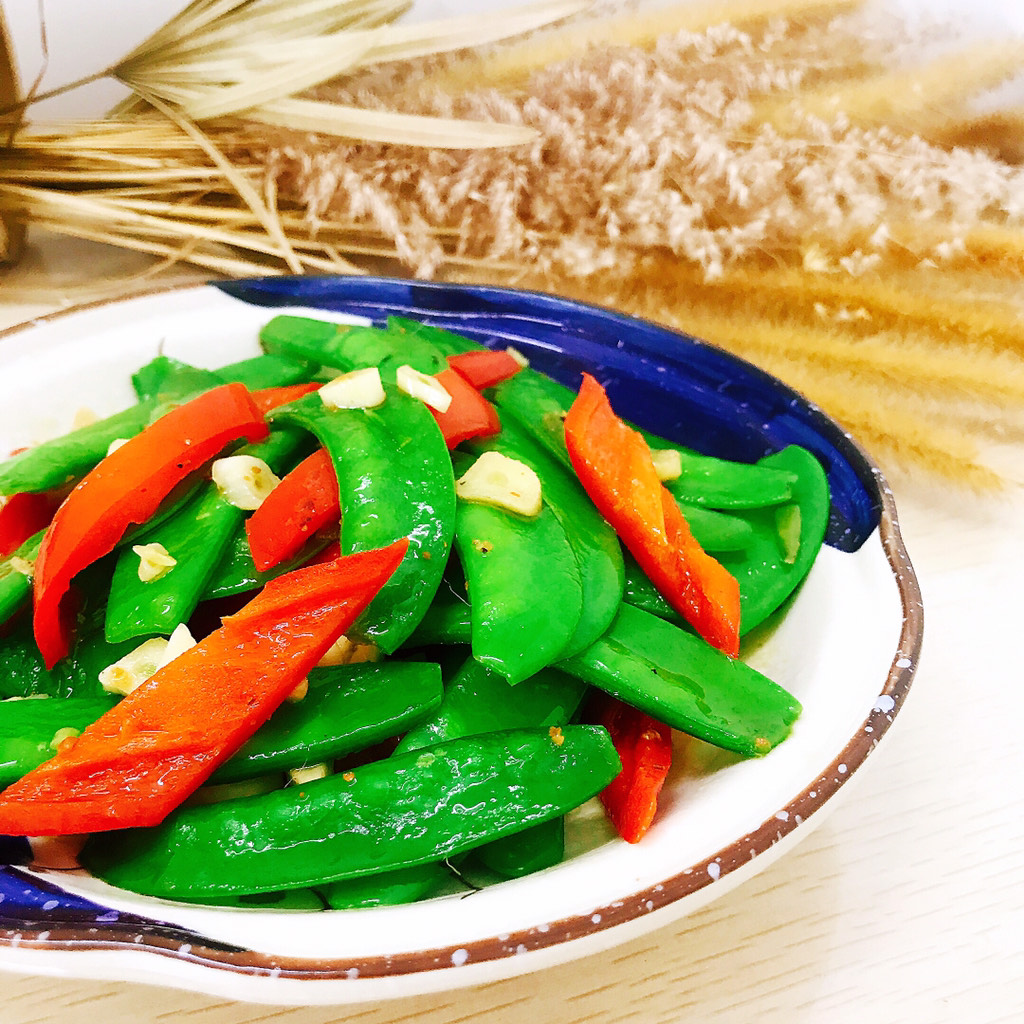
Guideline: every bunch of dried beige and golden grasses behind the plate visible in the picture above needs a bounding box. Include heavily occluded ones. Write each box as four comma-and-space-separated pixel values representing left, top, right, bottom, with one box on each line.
0, 0, 1024, 486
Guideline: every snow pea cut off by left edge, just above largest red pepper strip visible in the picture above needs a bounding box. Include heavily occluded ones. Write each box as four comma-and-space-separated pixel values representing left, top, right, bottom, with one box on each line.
0, 697, 117, 788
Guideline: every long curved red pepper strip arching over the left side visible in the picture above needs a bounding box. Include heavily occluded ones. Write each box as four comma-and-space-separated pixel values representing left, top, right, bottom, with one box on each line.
33, 384, 267, 668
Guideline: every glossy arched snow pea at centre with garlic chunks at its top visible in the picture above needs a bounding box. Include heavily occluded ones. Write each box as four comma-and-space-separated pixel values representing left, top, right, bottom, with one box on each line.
270, 386, 455, 654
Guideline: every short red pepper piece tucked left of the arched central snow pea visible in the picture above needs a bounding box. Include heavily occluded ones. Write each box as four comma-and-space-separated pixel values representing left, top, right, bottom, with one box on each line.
246, 449, 341, 572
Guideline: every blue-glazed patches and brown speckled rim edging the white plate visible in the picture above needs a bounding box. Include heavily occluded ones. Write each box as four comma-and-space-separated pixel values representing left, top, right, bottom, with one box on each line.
0, 276, 924, 981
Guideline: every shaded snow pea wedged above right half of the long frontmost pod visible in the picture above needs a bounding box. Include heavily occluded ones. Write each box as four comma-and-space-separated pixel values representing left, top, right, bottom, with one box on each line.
395, 657, 587, 754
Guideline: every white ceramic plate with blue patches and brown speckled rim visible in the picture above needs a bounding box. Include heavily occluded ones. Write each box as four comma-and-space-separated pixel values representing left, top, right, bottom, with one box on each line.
0, 278, 922, 1004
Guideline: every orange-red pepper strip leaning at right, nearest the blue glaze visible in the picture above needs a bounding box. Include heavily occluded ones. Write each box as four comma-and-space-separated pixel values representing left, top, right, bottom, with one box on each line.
565, 374, 739, 657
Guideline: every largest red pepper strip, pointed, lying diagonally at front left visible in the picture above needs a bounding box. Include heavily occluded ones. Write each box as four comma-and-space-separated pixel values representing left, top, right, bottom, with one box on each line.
0, 538, 409, 836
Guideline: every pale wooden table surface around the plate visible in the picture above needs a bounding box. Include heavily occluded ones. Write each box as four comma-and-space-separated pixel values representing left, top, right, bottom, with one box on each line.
0, 235, 1024, 1024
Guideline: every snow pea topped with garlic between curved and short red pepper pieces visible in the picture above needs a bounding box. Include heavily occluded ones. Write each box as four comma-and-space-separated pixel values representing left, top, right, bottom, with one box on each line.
105, 429, 305, 643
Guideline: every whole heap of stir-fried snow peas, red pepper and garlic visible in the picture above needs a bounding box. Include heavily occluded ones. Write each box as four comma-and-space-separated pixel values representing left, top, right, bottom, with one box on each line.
0, 315, 829, 908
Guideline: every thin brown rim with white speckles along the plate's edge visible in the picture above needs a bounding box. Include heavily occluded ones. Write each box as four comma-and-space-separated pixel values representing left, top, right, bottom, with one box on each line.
0, 284, 924, 983
